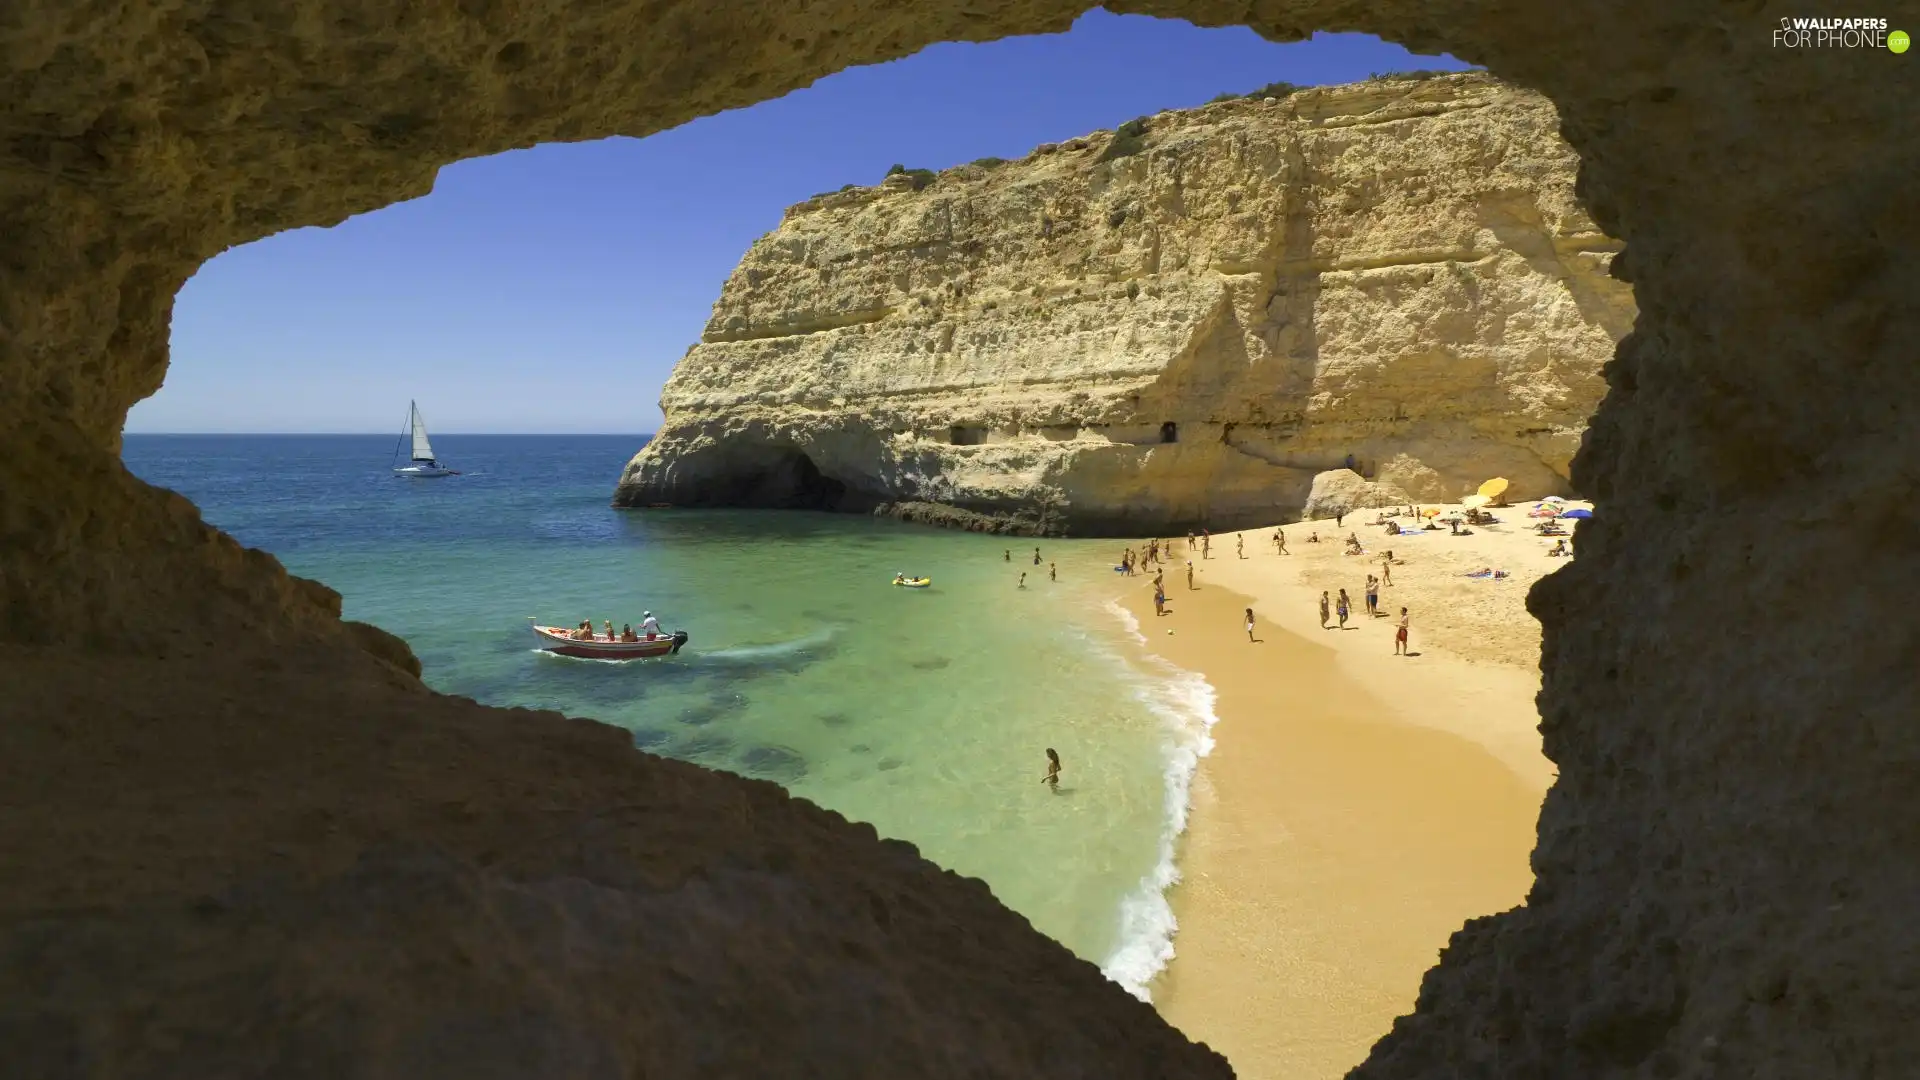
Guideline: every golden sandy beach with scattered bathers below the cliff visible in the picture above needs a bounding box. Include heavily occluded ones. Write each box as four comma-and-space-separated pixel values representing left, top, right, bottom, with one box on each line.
1119, 505, 1561, 1080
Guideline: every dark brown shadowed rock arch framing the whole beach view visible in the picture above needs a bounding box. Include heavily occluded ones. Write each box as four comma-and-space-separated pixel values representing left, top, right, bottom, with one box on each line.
0, 0, 1920, 1078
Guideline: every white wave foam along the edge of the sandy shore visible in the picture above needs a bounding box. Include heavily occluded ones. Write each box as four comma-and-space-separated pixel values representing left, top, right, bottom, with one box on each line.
1100, 641, 1219, 1001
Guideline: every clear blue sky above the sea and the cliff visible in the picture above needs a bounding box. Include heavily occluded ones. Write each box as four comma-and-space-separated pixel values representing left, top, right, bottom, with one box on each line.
127, 12, 1465, 434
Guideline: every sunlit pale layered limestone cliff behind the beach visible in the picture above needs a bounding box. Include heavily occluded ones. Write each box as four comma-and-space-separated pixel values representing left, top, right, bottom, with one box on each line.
614, 75, 1634, 536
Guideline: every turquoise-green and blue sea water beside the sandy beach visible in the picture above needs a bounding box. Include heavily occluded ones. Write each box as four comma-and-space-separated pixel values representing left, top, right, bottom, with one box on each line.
125, 436, 1212, 995
